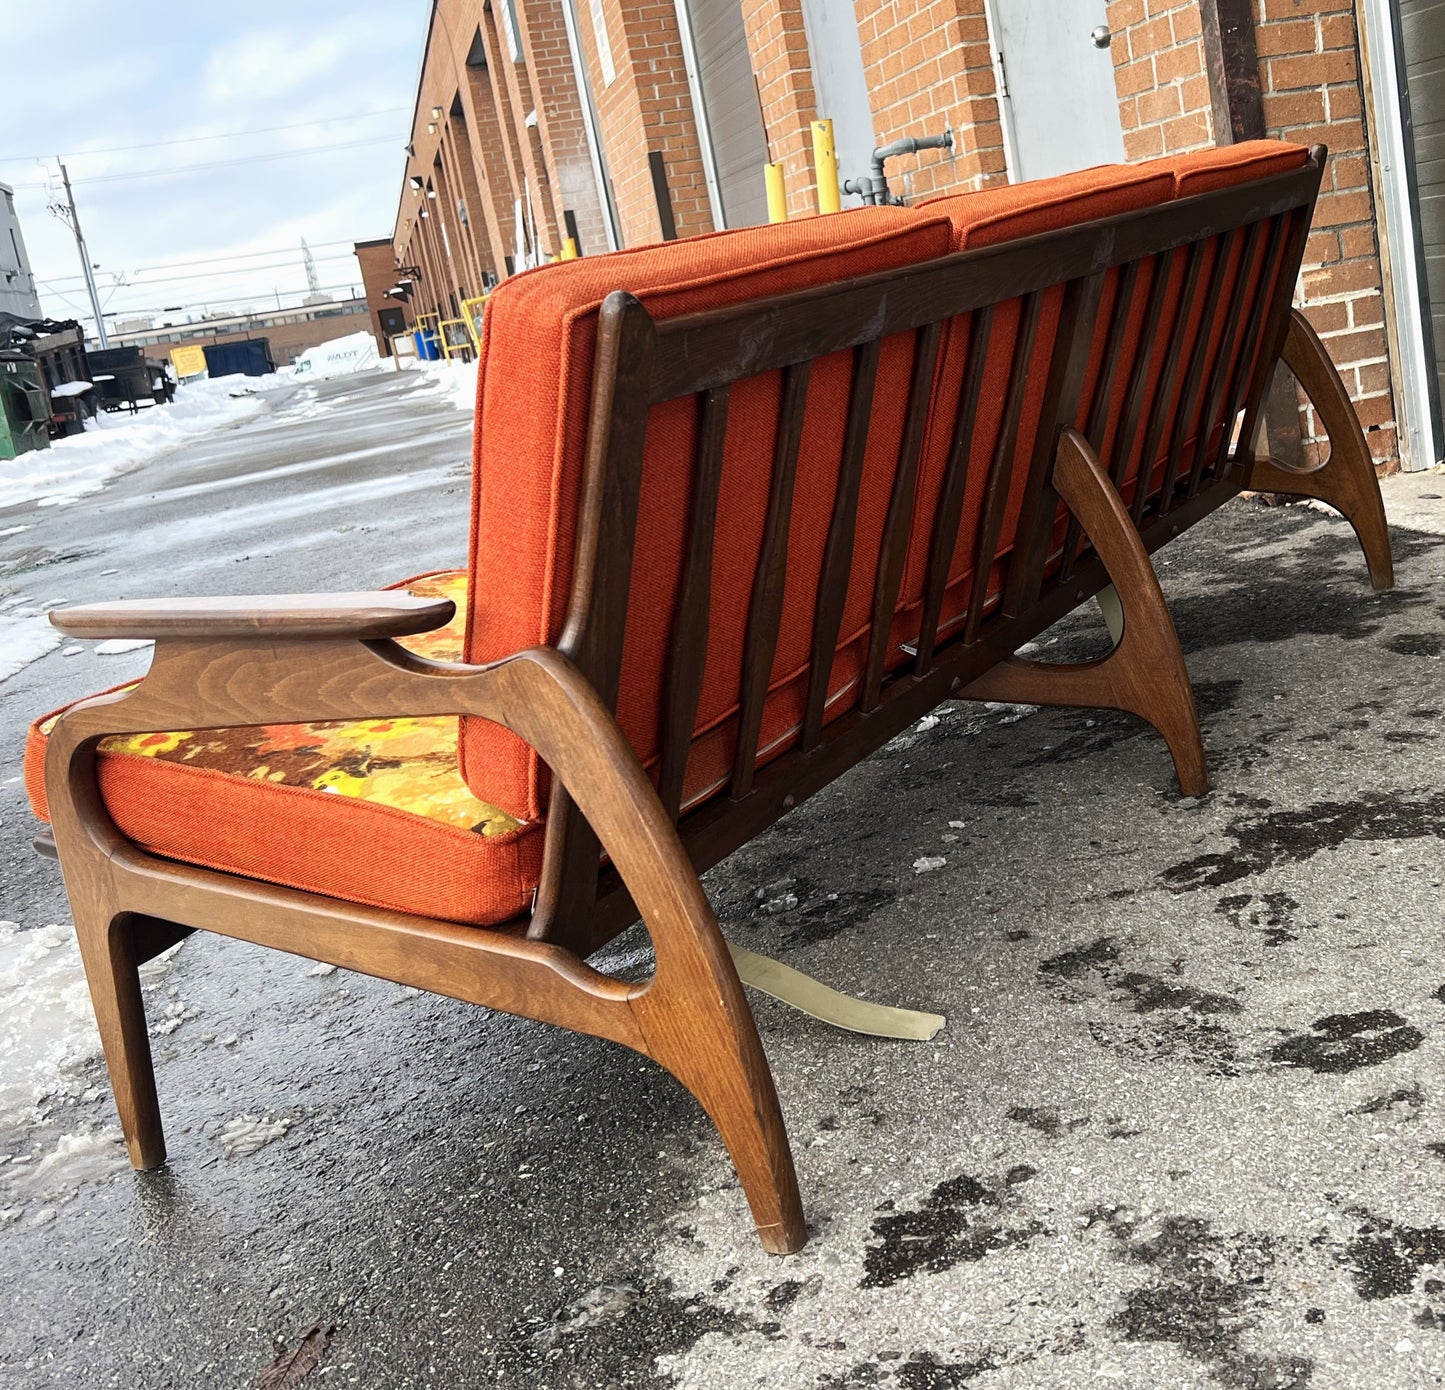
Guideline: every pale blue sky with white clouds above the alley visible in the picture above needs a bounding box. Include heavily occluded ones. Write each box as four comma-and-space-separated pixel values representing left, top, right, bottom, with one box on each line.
0, 0, 431, 333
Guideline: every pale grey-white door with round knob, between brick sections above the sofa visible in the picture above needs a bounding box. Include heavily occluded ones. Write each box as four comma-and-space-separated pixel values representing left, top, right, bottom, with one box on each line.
988, 0, 1124, 184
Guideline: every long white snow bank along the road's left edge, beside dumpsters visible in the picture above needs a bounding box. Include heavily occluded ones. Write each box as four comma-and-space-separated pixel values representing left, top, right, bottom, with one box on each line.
0, 377, 264, 507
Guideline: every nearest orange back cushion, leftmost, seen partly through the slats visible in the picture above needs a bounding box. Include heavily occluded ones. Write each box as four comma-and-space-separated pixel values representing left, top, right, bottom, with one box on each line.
462, 200, 949, 819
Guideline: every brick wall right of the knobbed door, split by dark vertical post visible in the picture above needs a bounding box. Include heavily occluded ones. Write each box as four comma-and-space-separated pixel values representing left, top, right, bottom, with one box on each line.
1108, 0, 1399, 471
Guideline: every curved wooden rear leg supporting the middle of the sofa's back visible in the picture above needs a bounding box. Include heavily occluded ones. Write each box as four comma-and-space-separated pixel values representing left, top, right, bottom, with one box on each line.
961, 429, 1209, 796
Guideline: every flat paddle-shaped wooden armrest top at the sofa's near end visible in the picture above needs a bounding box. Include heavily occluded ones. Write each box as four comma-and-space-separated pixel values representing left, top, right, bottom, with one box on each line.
51, 590, 457, 642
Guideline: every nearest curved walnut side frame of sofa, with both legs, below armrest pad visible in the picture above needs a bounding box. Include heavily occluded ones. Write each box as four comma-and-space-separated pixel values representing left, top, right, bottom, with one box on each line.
45, 642, 805, 1253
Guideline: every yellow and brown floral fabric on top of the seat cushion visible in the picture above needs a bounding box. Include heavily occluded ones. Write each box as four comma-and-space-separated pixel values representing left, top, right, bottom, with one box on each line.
40, 569, 520, 837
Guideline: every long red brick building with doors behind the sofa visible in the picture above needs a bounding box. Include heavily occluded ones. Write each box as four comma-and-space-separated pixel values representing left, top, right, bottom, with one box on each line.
373, 0, 1445, 468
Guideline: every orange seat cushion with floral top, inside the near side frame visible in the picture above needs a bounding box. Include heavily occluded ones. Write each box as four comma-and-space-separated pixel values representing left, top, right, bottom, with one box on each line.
25, 571, 543, 926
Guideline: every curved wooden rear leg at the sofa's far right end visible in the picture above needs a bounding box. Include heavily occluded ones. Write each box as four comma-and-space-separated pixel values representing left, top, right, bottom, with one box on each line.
1244, 309, 1394, 590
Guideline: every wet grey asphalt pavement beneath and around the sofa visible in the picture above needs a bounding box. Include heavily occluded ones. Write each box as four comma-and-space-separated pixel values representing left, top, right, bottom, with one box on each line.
0, 374, 1445, 1390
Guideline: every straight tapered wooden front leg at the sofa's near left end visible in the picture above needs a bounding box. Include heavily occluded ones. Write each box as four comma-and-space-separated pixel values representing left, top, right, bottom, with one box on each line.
75, 907, 166, 1167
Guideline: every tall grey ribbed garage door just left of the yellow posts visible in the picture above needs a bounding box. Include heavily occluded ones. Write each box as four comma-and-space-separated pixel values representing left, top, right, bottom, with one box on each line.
678, 0, 767, 227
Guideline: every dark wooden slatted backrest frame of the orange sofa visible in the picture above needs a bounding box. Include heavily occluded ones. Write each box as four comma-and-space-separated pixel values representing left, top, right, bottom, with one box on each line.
533, 149, 1324, 949
